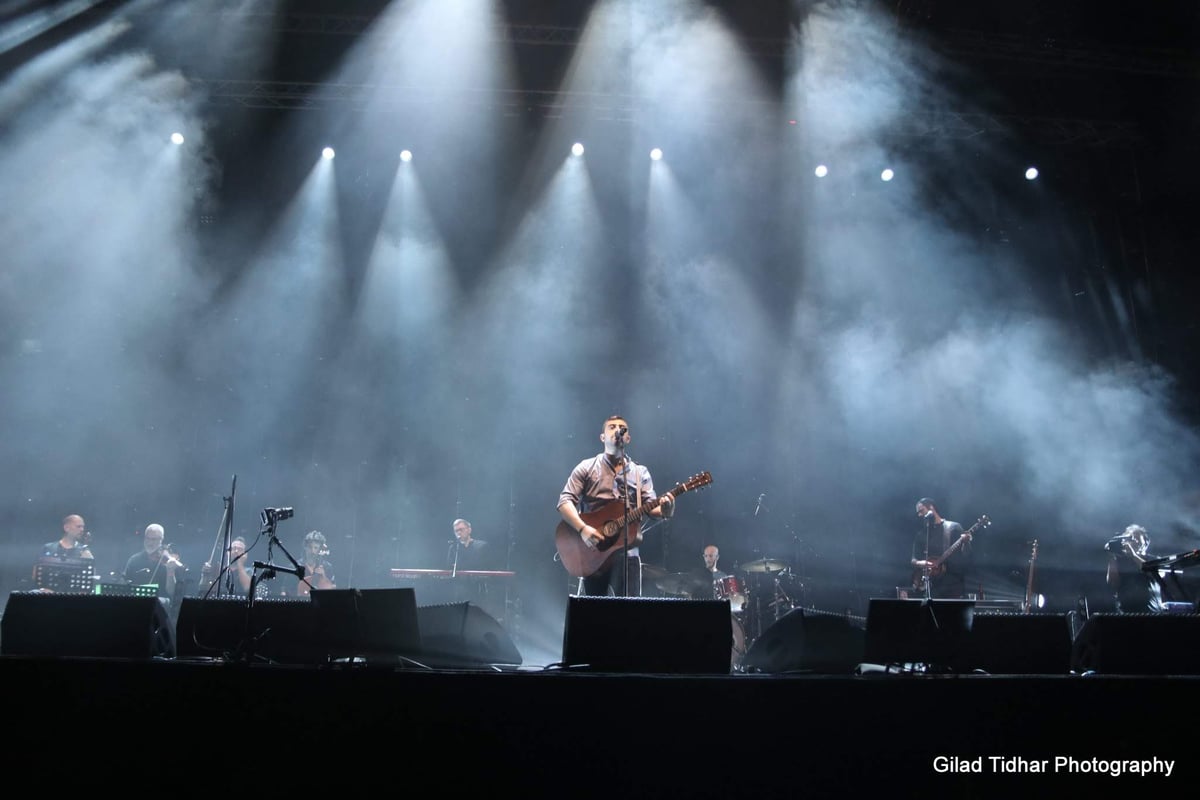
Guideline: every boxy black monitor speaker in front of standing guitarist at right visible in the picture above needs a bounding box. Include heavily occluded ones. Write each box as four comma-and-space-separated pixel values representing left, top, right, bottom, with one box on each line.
864, 597, 974, 670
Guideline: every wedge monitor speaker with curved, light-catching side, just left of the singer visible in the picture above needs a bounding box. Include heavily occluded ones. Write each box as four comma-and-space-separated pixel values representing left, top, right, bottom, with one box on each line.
416, 602, 523, 667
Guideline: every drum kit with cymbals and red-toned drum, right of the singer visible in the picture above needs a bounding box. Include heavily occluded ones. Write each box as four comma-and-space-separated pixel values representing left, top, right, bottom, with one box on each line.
643, 558, 804, 672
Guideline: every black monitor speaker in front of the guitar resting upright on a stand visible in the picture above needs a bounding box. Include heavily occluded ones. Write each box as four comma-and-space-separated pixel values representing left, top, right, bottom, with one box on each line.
956, 610, 1074, 675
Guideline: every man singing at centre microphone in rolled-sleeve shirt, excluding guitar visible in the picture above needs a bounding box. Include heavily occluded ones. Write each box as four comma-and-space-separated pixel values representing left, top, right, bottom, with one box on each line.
556, 415, 674, 597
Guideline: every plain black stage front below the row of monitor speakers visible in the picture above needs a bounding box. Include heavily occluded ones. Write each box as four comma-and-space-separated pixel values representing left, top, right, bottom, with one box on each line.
0, 656, 1200, 798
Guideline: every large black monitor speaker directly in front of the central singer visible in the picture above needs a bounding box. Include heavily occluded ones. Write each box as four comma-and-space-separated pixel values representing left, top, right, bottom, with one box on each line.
563, 597, 733, 674
